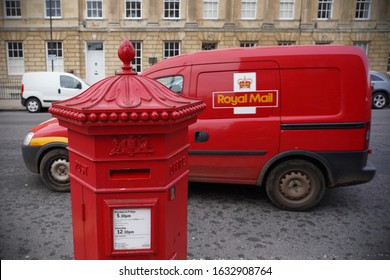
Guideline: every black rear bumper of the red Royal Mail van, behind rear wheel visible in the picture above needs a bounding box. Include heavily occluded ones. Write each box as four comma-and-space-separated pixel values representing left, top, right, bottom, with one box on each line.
319, 151, 376, 187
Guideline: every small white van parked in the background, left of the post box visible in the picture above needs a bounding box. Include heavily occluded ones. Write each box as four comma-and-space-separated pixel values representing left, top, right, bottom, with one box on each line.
21, 72, 89, 113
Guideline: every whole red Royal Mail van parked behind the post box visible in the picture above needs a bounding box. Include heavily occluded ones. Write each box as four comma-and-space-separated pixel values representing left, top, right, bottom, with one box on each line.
22, 46, 375, 210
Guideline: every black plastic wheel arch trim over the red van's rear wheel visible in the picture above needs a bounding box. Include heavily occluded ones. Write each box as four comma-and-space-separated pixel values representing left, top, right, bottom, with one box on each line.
257, 150, 335, 187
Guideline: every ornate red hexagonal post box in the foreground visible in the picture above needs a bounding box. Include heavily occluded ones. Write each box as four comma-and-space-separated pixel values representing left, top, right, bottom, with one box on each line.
49, 40, 205, 259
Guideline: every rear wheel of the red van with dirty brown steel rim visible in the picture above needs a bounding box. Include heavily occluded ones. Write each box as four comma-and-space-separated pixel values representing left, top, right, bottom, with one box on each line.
266, 159, 326, 211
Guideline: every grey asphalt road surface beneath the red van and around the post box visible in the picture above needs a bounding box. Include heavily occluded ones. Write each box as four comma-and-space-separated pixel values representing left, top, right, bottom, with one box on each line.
0, 108, 390, 260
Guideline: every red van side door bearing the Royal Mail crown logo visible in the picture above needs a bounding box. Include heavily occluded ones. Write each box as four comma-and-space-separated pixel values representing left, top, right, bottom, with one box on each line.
189, 61, 280, 184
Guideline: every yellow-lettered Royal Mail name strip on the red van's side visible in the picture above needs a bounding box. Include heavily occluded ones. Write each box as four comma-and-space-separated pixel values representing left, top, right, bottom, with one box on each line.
213, 90, 278, 109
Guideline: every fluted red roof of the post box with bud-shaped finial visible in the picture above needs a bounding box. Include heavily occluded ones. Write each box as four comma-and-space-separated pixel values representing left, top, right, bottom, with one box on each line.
49, 40, 205, 125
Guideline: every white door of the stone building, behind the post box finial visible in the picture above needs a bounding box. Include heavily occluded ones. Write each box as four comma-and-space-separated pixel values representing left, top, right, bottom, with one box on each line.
86, 42, 105, 85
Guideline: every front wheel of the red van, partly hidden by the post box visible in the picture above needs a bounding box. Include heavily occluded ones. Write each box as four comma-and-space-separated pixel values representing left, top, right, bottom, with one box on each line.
39, 149, 70, 192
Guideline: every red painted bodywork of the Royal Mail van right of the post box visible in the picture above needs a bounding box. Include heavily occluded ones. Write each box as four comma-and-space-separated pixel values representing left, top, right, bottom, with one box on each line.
143, 46, 371, 186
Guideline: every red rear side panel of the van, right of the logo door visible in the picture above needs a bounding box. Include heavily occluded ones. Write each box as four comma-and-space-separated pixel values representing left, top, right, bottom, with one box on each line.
280, 56, 371, 152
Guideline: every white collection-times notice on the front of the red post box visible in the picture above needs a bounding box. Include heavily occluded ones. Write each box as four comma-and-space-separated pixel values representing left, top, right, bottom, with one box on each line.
113, 208, 151, 250
